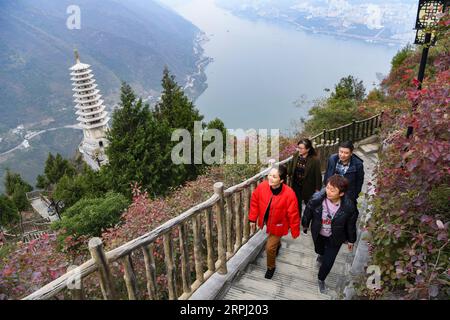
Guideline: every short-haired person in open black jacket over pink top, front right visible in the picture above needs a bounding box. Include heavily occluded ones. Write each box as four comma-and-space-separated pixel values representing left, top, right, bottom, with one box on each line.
302, 175, 358, 293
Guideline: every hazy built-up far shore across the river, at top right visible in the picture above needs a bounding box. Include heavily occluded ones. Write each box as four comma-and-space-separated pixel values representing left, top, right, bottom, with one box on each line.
216, 0, 417, 45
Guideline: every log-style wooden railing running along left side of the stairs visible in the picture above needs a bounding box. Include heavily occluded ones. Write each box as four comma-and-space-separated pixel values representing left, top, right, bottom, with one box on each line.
24, 115, 380, 300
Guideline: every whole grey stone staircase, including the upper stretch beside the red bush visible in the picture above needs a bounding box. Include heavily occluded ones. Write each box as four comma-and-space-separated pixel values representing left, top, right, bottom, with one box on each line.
217, 137, 379, 300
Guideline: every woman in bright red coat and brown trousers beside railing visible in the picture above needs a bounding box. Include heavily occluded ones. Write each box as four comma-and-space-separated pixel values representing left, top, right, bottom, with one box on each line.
249, 165, 300, 279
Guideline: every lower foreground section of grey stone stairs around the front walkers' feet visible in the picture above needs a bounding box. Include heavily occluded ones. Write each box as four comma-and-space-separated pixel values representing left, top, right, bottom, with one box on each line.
222, 234, 352, 300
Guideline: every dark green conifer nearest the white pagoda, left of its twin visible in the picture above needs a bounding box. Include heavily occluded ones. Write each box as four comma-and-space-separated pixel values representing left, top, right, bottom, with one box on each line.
105, 83, 186, 198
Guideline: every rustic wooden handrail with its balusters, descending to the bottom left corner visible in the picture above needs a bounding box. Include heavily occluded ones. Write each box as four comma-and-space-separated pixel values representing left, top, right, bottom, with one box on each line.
24, 114, 381, 300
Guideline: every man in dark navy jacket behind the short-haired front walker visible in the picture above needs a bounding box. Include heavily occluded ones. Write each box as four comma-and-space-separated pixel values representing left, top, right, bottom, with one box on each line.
323, 141, 364, 205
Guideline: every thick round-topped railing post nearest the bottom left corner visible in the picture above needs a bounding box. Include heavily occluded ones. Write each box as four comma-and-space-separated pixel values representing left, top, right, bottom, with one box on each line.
89, 238, 116, 300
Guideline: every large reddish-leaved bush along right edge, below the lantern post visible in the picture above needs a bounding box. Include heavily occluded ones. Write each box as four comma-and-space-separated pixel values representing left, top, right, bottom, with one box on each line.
368, 55, 450, 299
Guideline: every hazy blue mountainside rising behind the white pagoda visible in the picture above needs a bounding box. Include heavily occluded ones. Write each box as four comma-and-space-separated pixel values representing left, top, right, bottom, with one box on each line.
0, 0, 204, 133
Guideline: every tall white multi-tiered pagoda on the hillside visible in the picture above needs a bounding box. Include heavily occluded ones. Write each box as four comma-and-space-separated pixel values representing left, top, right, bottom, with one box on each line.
70, 50, 110, 170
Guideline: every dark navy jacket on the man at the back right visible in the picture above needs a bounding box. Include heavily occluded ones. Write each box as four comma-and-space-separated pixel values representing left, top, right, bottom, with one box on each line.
323, 154, 364, 202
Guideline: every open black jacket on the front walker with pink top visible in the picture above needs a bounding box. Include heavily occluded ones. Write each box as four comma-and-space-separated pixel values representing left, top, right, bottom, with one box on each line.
302, 189, 358, 246
